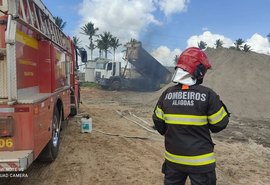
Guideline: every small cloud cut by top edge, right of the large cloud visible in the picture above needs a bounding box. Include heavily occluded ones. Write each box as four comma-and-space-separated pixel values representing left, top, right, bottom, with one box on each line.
159, 0, 190, 16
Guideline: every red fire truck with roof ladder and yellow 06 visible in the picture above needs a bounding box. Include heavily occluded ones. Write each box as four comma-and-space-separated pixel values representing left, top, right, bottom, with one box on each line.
0, 0, 83, 172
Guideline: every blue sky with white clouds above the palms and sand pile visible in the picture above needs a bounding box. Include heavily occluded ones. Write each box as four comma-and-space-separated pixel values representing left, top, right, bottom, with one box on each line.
43, 0, 270, 65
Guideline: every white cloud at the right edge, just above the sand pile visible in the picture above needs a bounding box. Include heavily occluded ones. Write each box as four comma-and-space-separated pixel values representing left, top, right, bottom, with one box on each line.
246, 33, 270, 55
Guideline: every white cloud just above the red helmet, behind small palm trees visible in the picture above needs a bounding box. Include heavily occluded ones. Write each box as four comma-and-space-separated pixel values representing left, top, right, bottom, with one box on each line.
187, 31, 233, 47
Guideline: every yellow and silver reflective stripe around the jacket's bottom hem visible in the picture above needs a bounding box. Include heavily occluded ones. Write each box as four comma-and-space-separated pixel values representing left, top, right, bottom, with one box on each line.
165, 151, 216, 166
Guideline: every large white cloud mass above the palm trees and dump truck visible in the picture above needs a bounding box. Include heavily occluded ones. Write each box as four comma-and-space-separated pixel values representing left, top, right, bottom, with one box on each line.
74, 0, 190, 55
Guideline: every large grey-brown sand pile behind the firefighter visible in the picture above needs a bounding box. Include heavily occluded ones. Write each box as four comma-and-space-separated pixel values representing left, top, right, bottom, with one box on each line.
148, 48, 270, 120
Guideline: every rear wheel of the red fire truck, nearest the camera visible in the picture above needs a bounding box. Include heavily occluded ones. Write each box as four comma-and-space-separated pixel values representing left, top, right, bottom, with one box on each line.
38, 108, 60, 162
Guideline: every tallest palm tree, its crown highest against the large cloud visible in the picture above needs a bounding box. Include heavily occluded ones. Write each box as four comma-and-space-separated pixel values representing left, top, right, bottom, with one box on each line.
81, 22, 98, 60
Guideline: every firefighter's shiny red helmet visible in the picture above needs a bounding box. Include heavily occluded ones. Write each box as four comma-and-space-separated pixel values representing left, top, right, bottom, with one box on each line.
176, 47, 211, 77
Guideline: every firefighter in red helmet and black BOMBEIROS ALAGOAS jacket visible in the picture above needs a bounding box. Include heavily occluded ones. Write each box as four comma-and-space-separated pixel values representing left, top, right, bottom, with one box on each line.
152, 47, 230, 185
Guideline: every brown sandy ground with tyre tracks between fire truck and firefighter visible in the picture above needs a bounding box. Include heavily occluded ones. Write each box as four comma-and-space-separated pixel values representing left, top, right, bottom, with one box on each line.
0, 88, 270, 185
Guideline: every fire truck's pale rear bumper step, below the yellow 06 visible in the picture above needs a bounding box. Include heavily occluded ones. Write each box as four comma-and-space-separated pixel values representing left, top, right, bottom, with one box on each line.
0, 150, 34, 172
